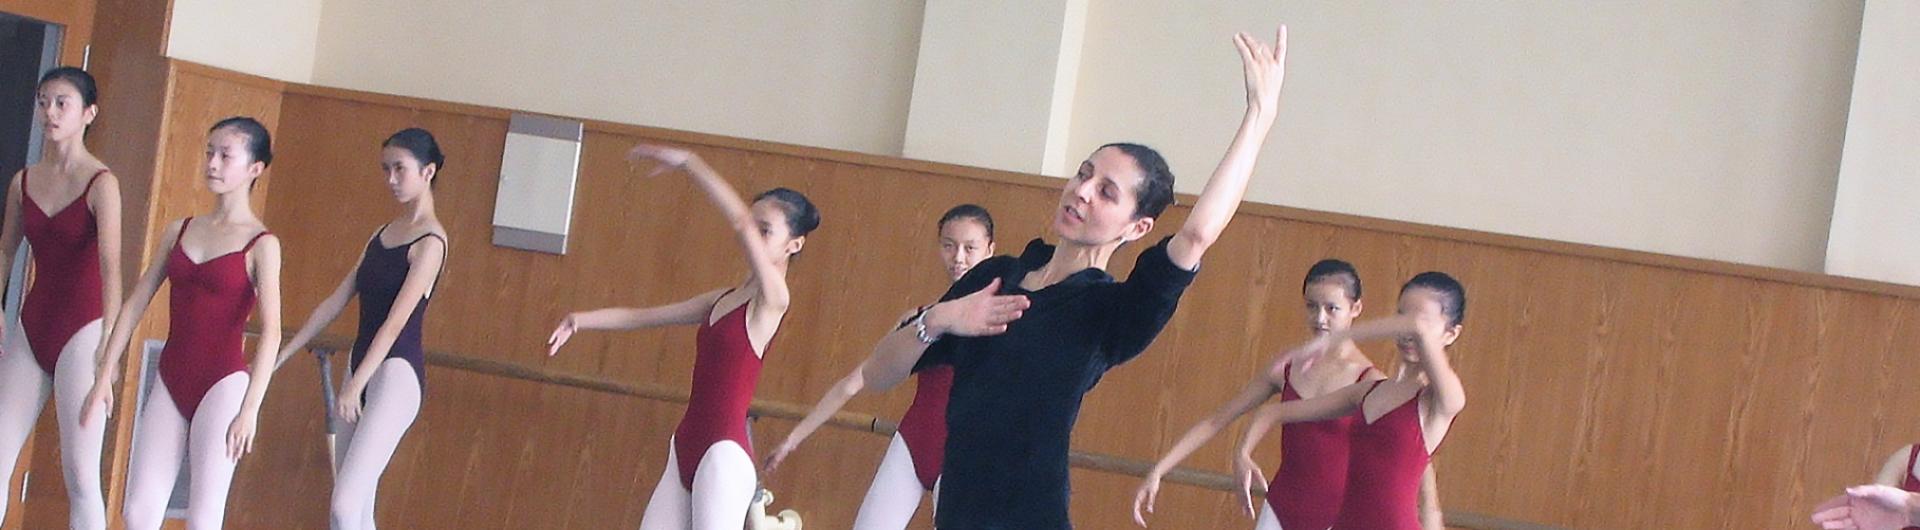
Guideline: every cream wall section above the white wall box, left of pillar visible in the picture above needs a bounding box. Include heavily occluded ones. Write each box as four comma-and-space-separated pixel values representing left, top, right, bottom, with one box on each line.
313, 0, 924, 156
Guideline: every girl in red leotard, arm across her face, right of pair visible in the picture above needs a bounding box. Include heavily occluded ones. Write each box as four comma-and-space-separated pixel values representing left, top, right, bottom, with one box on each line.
1133, 273, 1467, 530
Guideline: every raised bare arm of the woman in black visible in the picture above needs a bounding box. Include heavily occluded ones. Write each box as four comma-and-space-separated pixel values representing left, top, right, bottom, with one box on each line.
1167, 25, 1286, 271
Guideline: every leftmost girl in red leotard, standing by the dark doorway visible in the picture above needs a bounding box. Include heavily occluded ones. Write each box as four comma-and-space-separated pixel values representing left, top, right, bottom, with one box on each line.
0, 67, 121, 530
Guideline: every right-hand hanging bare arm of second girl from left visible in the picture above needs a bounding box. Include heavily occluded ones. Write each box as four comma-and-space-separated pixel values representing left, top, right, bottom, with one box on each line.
227, 234, 280, 461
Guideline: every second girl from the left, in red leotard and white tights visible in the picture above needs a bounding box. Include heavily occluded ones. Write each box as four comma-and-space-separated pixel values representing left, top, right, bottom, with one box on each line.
81, 117, 280, 530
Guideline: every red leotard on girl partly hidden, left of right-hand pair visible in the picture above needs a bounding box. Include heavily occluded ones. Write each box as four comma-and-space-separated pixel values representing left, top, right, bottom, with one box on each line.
1267, 365, 1367, 528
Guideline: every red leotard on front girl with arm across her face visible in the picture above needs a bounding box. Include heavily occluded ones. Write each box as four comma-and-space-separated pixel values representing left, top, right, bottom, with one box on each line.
1332, 380, 1432, 530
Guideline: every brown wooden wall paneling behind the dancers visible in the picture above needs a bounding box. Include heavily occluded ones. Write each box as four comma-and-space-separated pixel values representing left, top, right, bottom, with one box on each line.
187, 75, 1920, 528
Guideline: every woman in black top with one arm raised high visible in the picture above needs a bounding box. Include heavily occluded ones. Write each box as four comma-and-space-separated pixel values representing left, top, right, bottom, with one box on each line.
862, 27, 1286, 528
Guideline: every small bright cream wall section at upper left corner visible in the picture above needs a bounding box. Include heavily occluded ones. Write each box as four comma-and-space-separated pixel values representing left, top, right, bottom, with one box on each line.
167, 0, 323, 83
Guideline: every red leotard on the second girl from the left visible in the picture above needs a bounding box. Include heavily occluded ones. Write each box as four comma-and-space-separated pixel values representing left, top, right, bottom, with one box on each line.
159, 217, 267, 421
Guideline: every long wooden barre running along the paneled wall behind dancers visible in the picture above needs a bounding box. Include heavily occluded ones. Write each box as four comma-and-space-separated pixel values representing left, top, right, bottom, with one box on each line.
284, 336, 1565, 530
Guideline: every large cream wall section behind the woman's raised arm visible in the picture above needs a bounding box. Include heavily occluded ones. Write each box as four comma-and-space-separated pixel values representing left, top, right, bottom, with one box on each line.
1069, 0, 1860, 271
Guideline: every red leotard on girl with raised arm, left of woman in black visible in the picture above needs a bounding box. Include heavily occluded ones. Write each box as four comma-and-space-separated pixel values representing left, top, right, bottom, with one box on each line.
674, 294, 760, 492
